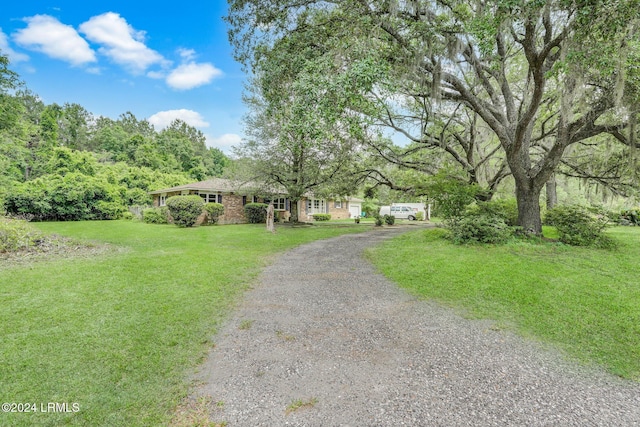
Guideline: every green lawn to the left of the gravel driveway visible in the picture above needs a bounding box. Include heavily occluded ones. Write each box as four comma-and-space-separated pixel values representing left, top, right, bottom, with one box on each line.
0, 221, 366, 426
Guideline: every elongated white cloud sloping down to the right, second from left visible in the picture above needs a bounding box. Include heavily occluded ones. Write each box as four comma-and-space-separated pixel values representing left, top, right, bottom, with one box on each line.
80, 12, 169, 73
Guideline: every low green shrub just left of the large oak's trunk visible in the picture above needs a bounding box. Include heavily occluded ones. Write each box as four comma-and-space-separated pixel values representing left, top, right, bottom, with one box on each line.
447, 214, 513, 244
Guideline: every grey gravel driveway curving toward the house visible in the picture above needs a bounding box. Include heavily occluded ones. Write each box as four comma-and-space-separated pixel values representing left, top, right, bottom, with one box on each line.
195, 227, 640, 427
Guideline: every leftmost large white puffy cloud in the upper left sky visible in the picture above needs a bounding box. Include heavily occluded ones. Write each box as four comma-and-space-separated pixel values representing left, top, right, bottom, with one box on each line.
13, 15, 96, 65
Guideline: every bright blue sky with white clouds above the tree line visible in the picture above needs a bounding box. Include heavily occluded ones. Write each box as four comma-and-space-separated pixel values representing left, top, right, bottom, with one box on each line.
0, 0, 245, 152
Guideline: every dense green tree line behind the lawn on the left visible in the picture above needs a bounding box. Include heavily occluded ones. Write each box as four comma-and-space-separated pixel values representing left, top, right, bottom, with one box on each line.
0, 52, 230, 220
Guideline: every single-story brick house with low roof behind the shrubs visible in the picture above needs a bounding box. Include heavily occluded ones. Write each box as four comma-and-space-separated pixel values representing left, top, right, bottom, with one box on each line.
149, 178, 363, 224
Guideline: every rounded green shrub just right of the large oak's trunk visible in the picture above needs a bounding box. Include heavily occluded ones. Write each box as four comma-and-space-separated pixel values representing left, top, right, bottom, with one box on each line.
545, 205, 612, 247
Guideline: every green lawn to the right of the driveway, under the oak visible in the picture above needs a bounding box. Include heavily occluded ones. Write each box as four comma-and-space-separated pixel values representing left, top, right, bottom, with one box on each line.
368, 227, 640, 381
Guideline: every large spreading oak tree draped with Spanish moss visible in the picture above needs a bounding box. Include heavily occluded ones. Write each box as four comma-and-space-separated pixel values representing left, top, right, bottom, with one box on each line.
227, 0, 640, 234
